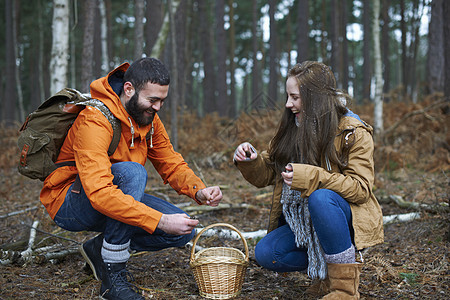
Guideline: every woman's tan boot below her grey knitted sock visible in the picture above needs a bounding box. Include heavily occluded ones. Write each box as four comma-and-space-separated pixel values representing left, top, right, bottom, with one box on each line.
322, 263, 362, 300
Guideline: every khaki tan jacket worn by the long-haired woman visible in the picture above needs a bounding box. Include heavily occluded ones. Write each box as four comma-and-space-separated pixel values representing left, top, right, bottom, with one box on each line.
236, 116, 384, 250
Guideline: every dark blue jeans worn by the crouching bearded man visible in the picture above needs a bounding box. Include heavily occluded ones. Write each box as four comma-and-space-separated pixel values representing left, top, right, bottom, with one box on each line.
54, 162, 195, 251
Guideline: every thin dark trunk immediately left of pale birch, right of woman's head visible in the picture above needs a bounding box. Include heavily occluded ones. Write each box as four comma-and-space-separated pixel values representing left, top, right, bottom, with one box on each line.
363, 0, 372, 100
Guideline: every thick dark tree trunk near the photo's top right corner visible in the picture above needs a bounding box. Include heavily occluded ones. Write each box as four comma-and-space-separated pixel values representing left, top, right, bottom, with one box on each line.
427, 0, 444, 94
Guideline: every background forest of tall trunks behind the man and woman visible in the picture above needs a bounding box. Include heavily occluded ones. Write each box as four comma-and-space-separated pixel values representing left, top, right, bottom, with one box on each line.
0, 0, 450, 139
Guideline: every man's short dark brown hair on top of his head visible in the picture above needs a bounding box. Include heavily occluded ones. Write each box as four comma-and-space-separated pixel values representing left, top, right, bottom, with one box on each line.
123, 57, 170, 91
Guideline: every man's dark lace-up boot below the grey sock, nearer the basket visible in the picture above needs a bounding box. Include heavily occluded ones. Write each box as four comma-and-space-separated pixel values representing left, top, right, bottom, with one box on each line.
100, 263, 144, 300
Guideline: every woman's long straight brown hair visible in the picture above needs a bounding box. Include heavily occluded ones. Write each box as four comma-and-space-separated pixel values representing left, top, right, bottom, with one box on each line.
268, 61, 350, 173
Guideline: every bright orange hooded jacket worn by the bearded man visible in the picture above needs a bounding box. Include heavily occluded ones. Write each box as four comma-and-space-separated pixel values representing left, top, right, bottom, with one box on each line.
40, 63, 205, 233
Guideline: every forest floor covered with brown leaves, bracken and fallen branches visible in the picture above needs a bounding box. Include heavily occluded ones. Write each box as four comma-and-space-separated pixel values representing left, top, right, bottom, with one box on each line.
0, 98, 450, 300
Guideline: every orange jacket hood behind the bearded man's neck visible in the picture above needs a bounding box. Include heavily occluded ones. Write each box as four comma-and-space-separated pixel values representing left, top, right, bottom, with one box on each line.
90, 63, 153, 138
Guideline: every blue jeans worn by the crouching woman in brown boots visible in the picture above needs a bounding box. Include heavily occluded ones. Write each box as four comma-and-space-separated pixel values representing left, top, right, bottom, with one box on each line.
255, 189, 353, 272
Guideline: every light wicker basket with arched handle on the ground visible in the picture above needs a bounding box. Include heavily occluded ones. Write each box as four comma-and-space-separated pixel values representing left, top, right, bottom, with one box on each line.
189, 223, 249, 299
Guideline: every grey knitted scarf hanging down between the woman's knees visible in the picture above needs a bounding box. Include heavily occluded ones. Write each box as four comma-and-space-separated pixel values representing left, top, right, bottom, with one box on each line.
280, 183, 327, 279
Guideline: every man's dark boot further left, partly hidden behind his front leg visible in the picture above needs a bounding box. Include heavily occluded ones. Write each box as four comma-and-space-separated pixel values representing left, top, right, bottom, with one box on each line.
80, 233, 105, 280
